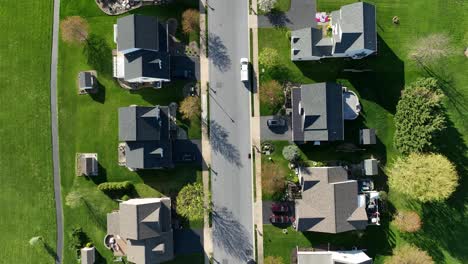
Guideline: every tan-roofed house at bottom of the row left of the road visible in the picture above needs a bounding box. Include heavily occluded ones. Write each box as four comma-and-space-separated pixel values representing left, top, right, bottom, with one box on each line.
104, 197, 174, 264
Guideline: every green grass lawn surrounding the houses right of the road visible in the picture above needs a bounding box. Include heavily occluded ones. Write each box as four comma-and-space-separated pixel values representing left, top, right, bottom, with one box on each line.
259, 0, 468, 263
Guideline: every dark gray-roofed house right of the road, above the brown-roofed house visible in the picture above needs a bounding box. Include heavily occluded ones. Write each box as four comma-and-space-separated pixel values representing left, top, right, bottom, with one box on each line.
291, 82, 344, 143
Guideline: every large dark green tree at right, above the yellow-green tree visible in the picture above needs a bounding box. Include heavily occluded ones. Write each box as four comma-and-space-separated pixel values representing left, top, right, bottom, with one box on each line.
393, 78, 445, 154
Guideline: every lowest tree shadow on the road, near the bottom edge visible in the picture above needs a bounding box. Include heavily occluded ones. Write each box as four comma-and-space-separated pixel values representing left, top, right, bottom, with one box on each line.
213, 207, 253, 263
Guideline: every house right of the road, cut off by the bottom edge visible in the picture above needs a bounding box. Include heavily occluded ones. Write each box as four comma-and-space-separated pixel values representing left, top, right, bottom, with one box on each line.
292, 248, 372, 264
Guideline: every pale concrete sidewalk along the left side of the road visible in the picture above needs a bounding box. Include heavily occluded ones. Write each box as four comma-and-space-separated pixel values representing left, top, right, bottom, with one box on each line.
199, 0, 213, 264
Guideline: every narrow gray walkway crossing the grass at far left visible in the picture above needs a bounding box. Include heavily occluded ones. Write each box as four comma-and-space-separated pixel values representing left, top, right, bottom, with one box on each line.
50, 0, 63, 264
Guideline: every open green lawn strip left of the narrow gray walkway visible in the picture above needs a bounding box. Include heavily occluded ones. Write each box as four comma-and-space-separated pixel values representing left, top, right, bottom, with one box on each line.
0, 1, 56, 263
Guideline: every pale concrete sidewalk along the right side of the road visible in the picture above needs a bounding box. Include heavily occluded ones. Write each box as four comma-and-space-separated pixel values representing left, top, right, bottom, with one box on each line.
249, 0, 263, 264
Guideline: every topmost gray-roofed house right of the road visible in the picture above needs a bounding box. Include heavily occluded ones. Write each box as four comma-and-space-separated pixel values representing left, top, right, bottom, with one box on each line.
291, 2, 377, 61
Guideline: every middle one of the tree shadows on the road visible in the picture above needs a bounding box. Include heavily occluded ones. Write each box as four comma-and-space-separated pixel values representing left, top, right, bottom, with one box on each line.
210, 120, 242, 167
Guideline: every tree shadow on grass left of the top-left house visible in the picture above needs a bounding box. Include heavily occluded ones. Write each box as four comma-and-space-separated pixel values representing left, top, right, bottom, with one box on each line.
83, 34, 112, 76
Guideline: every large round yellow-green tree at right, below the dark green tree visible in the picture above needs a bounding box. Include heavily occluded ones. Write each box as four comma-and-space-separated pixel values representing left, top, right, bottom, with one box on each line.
389, 153, 458, 202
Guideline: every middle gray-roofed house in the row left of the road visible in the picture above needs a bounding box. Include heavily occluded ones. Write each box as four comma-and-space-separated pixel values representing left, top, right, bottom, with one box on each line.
119, 106, 174, 170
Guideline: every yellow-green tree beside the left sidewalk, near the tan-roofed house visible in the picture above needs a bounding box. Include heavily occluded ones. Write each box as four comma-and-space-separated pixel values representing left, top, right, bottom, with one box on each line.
176, 183, 211, 220
